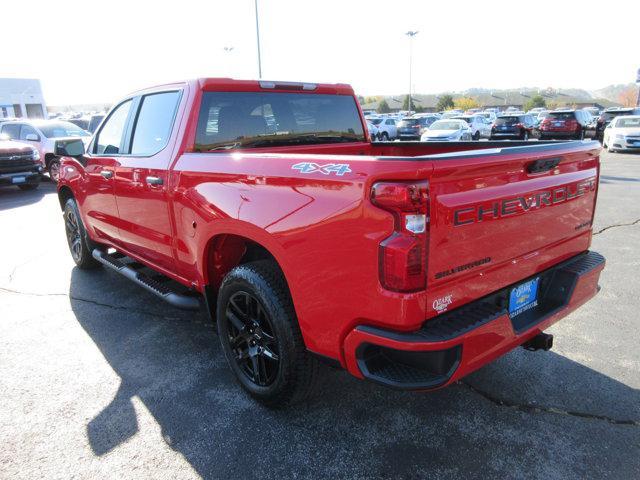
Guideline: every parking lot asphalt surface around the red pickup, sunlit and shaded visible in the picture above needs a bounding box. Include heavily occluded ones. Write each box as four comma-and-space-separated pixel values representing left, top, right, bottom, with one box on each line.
0, 153, 640, 479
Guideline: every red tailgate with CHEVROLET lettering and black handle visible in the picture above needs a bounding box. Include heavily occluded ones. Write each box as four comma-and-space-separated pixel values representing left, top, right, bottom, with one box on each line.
428, 142, 600, 316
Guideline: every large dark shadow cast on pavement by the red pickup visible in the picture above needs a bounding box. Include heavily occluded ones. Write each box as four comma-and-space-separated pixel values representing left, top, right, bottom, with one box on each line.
70, 268, 640, 478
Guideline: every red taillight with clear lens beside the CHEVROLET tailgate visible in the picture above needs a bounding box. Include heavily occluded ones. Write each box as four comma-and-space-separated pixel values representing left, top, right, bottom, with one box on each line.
371, 182, 429, 292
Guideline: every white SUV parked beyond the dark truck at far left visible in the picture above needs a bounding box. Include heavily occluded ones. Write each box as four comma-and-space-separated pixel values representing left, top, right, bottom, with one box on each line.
0, 120, 91, 182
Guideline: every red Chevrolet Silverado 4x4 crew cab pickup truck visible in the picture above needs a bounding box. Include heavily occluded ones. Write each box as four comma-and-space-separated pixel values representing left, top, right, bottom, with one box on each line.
56, 79, 605, 405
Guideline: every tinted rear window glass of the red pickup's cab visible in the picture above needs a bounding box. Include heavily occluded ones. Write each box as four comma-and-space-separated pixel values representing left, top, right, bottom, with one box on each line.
195, 92, 365, 152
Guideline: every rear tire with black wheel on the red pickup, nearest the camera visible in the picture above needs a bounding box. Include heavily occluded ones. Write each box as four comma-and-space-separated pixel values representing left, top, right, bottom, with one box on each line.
216, 260, 320, 408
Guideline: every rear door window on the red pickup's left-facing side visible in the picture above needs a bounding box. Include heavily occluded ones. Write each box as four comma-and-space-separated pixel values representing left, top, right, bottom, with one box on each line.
131, 91, 180, 155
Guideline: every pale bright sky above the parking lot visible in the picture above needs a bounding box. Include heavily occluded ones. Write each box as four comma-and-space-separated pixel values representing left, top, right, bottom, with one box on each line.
0, 0, 640, 105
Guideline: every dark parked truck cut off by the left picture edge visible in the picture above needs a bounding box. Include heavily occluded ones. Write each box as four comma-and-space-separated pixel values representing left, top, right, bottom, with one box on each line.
0, 136, 42, 190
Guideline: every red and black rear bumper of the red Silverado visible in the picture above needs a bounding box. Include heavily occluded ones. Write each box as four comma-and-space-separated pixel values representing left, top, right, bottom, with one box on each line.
344, 252, 605, 390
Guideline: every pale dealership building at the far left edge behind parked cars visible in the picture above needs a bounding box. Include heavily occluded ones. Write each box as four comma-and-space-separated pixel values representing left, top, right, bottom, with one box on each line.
0, 78, 48, 118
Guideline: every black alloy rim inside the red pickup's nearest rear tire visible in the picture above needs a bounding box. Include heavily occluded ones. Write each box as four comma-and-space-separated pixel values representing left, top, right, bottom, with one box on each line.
225, 291, 280, 387
